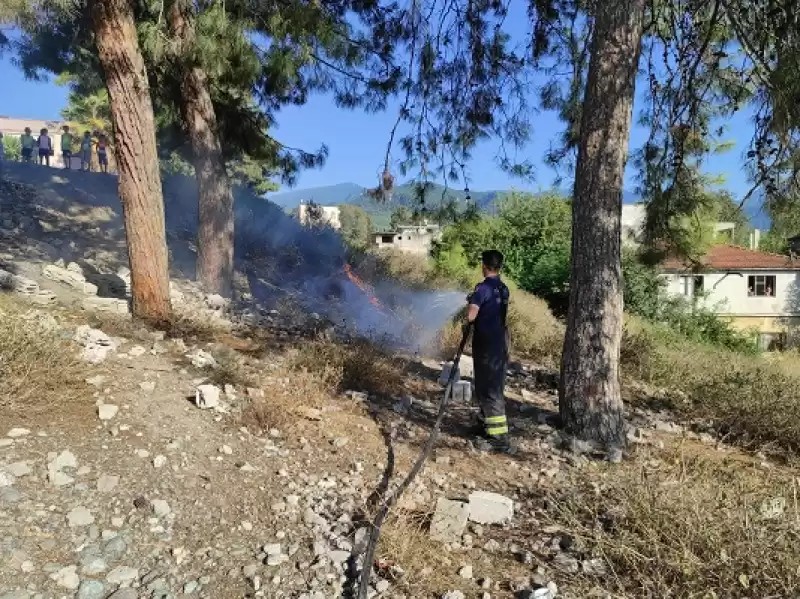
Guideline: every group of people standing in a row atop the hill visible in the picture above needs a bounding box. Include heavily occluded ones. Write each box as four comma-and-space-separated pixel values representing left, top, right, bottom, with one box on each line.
0, 125, 108, 173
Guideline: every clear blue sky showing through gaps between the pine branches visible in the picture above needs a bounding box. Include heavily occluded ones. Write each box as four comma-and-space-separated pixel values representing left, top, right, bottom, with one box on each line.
0, 48, 752, 202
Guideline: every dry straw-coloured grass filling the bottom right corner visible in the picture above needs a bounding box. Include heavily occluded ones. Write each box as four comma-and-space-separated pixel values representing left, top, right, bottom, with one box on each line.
545, 447, 800, 598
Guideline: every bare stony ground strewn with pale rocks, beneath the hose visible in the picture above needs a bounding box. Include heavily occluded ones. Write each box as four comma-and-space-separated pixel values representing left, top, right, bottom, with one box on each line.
0, 168, 776, 599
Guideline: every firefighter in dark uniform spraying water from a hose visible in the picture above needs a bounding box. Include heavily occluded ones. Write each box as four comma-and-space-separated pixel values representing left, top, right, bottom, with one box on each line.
466, 250, 515, 453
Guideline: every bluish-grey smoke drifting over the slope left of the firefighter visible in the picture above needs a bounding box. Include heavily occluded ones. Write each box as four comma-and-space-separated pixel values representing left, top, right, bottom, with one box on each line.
165, 177, 464, 351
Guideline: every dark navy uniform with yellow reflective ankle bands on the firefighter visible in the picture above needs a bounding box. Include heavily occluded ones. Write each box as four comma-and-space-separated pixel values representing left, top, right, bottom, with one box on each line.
469, 276, 510, 439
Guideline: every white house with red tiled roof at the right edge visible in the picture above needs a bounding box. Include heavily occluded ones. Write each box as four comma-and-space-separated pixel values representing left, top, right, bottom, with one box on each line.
662, 245, 800, 348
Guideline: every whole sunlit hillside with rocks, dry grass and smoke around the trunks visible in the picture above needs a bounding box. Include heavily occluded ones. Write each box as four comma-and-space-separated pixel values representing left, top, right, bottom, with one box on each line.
0, 165, 800, 599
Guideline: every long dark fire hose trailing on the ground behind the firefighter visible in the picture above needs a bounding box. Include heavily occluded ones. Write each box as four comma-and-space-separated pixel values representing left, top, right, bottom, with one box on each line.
356, 323, 472, 599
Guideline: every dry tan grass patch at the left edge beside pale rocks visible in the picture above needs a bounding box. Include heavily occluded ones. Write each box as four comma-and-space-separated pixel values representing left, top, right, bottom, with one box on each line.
0, 293, 86, 413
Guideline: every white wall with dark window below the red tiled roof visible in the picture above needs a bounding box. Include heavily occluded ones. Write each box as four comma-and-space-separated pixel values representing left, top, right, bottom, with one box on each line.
664, 270, 800, 326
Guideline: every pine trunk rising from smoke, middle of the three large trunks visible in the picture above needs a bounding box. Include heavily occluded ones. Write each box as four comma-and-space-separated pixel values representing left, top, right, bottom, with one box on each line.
170, 0, 234, 297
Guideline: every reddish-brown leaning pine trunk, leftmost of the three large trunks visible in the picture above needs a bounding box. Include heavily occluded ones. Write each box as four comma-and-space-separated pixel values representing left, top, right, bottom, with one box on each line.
91, 0, 172, 324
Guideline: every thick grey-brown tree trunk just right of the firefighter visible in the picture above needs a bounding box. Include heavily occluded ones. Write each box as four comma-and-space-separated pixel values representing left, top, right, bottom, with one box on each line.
559, 0, 645, 449
